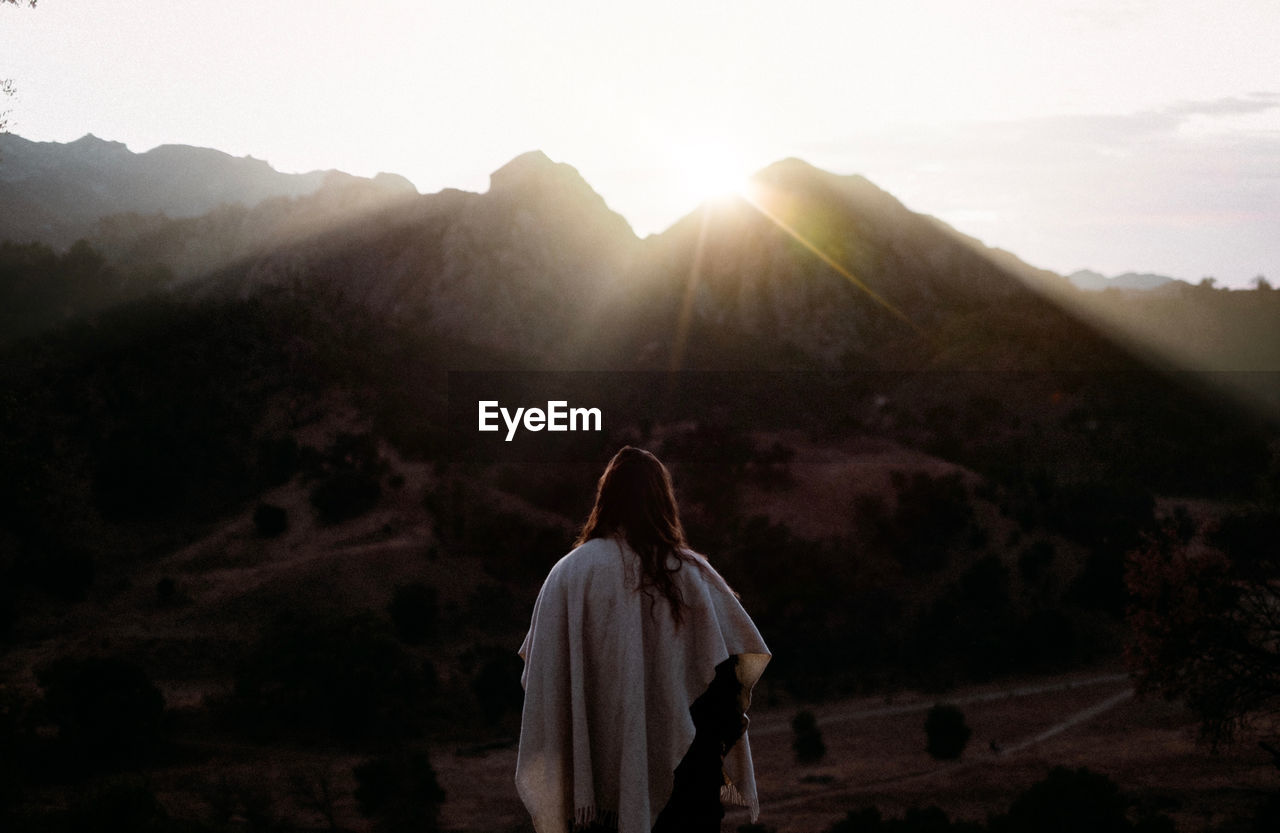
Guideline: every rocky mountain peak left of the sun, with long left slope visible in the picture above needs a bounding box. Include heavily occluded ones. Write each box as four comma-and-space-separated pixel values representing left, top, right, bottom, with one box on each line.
188, 151, 641, 366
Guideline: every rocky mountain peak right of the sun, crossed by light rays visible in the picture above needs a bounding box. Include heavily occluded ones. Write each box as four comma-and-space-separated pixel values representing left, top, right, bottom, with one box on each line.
629, 159, 1121, 369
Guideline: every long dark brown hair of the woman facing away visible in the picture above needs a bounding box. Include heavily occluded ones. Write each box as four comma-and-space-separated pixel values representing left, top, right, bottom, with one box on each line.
576, 445, 691, 623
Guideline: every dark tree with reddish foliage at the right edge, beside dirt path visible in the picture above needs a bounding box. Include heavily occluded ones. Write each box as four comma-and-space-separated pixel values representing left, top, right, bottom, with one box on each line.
1125, 509, 1280, 746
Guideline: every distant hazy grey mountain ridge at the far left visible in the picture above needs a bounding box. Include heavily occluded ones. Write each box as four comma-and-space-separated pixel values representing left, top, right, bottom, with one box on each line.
0, 133, 415, 248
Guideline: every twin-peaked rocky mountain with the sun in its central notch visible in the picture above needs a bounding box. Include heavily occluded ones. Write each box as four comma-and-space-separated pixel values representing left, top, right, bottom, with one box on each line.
185, 151, 1114, 369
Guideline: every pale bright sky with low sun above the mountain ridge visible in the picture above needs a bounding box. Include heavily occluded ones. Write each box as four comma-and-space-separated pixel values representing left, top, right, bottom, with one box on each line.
0, 0, 1280, 287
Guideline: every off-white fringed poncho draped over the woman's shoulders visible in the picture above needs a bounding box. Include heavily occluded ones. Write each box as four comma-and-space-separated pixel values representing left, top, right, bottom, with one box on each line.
516, 539, 769, 833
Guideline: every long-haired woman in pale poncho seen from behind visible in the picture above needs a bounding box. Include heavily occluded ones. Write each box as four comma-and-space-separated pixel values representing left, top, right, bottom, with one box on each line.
516, 445, 769, 833
